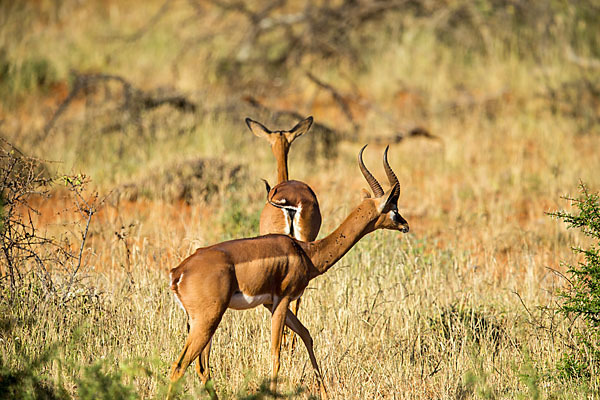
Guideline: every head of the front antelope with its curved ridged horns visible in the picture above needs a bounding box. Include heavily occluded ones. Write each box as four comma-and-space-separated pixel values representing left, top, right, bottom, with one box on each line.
358, 145, 409, 233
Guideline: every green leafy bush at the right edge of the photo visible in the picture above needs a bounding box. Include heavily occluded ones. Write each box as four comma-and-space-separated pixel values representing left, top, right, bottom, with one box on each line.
550, 184, 600, 378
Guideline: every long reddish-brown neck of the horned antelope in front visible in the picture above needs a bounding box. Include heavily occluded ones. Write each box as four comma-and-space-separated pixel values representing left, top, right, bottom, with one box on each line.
303, 202, 377, 279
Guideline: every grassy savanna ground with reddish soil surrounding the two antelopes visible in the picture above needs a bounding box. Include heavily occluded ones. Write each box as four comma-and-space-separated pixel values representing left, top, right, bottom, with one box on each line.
0, 0, 600, 399
